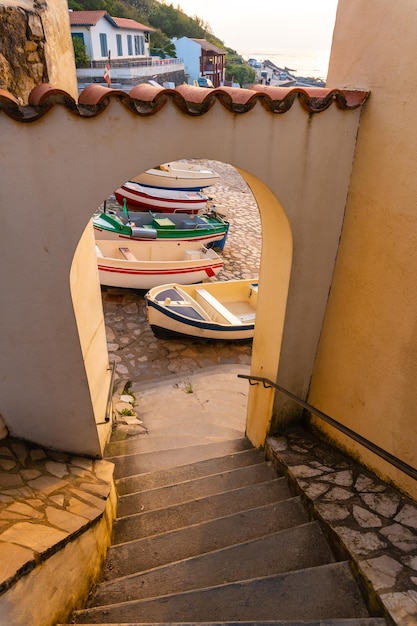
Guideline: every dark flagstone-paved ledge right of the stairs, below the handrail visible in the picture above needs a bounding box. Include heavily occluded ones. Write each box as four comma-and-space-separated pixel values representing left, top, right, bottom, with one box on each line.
267, 430, 417, 626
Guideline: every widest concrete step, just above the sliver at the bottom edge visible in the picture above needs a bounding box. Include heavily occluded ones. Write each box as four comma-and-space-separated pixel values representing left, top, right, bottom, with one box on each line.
74, 562, 368, 624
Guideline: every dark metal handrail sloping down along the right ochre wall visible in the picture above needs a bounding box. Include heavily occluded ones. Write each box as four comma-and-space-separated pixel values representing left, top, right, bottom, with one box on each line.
237, 374, 417, 480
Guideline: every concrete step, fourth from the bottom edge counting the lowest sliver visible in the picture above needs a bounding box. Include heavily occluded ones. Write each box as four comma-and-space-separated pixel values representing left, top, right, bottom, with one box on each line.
104, 498, 308, 580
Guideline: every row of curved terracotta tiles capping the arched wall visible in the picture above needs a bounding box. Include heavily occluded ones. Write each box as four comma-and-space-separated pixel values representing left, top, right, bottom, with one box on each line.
0, 83, 369, 122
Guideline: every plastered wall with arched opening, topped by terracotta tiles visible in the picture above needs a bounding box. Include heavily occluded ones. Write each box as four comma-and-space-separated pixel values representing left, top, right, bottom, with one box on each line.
0, 85, 364, 455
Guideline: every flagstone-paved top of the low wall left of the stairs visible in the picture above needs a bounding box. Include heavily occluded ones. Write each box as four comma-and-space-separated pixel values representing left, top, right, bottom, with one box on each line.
0, 438, 114, 593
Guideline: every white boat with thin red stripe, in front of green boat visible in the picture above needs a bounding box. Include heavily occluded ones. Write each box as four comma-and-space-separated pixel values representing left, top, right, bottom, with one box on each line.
96, 240, 223, 290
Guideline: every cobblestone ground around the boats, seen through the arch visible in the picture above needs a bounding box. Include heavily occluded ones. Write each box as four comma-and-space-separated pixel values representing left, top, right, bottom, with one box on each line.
102, 161, 261, 382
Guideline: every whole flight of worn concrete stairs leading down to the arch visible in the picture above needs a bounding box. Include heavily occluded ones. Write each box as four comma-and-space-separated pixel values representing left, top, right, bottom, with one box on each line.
64, 430, 386, 626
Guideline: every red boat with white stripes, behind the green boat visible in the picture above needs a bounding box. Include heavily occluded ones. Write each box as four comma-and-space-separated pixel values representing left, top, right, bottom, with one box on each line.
114, 181, 209, 214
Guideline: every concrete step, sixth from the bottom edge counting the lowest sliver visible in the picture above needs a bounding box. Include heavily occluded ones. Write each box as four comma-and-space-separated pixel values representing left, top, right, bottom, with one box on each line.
117, 463, 276, 517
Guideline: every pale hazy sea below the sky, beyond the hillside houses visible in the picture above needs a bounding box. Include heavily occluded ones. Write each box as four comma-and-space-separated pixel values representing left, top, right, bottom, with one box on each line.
239, 48, 330, 81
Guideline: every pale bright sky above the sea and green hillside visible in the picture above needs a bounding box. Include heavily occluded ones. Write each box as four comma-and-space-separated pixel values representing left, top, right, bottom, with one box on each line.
174, 0, 337, 54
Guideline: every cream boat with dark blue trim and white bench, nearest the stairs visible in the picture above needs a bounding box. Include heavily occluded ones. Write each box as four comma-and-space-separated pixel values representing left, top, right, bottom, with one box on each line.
145, 281, 257, 341
